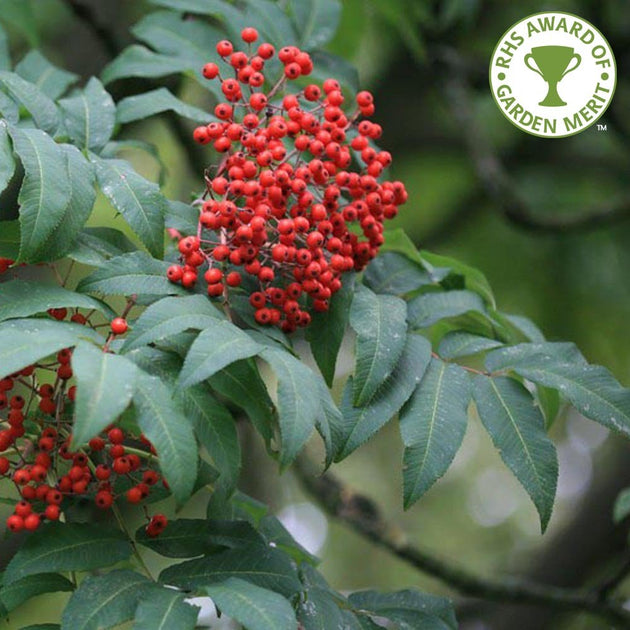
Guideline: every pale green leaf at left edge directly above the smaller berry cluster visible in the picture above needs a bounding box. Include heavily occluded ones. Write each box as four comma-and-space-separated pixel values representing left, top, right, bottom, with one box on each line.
0, 318, 105, 378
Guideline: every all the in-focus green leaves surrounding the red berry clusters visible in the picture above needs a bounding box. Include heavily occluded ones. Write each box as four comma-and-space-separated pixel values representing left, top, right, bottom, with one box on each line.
0, 0, 630, 630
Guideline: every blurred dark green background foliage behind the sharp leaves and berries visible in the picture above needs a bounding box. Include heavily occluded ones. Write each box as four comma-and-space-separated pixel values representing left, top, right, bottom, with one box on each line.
0, 0, 630, 630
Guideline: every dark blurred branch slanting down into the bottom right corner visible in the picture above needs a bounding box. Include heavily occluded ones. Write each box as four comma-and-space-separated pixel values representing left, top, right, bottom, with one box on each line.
295, 456, 630, 628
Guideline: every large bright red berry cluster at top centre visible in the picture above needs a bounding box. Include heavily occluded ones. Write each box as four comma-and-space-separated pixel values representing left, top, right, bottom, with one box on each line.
167, 28, 407, 332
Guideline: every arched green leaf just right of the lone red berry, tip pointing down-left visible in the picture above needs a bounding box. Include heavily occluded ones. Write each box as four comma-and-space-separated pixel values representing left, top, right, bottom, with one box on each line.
122, 295, 223, 352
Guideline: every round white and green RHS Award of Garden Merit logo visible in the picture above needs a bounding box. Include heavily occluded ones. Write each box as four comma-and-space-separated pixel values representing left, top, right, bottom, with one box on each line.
490, 11, 617, 138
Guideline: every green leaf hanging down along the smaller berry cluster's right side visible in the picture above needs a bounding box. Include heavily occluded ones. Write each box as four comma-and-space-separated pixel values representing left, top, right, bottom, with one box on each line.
133, 372, 198, 503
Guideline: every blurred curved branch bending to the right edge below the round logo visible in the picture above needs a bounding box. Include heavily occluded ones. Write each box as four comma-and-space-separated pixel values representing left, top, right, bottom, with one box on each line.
436, 49, 630, 233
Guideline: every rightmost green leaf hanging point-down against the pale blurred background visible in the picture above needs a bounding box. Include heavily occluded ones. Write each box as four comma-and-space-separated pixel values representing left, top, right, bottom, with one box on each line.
473, 375, 558, 532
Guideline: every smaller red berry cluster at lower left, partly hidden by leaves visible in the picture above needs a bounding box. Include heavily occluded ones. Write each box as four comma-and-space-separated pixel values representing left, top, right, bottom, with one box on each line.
0, 308, 168, 536
